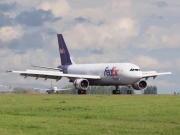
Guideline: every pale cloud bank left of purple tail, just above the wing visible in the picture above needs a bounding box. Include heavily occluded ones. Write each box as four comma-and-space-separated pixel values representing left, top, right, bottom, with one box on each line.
0, 49, 57, 71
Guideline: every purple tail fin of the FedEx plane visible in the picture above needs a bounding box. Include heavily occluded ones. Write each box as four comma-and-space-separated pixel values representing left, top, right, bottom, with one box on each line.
57, 34, 72, 65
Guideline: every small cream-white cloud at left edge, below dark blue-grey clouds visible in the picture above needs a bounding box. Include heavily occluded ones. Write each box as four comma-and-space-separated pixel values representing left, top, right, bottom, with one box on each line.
0, 26, 24, 42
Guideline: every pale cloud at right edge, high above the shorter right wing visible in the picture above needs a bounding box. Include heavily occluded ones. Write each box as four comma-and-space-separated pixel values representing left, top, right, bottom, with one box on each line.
138, 25, 180, 51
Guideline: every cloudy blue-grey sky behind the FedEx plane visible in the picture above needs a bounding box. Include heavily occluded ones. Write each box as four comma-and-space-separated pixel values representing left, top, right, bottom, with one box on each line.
0, 0, 180, 94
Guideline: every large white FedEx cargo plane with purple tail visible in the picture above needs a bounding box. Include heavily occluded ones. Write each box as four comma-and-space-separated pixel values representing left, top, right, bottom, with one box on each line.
6, 34, 172, 94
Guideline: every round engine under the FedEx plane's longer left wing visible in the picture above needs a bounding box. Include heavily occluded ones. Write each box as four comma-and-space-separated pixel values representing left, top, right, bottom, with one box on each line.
74, 79, 89, 90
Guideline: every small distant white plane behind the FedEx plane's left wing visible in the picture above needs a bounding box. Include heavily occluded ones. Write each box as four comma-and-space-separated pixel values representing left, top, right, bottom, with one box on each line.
34, 82, 71, 94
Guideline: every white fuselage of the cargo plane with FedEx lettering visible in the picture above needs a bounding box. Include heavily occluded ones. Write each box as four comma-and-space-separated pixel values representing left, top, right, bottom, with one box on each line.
67, 63, 142, 85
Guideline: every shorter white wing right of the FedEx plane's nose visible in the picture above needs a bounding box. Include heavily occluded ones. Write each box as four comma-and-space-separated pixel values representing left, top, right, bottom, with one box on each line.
142, 71, 172, 79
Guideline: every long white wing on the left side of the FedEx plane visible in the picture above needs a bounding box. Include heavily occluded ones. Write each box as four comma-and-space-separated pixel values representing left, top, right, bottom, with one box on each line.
6, 70, 101, 81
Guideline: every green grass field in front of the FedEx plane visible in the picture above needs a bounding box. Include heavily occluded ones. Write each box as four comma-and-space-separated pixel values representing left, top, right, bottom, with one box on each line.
0, 94, 180, 135
